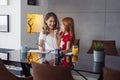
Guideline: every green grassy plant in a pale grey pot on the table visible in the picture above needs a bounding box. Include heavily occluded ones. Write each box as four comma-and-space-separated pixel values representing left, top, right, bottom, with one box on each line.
93, 42, 105, 62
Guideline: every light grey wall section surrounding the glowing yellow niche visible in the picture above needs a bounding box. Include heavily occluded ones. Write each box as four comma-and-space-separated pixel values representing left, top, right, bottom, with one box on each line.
21, 0, 48, 48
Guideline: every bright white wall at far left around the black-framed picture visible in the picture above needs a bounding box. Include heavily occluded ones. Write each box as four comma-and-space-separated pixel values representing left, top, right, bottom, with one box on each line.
0, 0, 21, 49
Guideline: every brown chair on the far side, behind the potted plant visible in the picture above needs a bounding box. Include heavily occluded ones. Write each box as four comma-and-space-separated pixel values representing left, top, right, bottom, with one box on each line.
87, 40, 118, 56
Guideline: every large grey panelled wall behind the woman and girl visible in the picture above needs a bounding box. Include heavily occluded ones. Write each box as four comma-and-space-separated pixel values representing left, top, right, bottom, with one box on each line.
48, 0, 120, 52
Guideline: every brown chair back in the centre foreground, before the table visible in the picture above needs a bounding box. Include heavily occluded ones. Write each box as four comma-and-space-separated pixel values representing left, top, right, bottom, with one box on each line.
31, 62, 74, 80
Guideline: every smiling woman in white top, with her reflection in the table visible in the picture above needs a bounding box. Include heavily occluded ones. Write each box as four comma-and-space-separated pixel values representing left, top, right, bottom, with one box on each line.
39, 12, 60, 63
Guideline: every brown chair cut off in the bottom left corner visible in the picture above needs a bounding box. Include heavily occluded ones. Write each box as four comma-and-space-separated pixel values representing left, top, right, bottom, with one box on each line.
0, 59, 33, 80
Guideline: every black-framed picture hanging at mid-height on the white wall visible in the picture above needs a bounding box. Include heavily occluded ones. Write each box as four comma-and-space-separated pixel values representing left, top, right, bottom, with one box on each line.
0, 15, 9, 32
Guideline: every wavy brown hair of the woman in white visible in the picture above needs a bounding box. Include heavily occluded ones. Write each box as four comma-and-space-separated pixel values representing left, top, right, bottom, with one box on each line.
42, 12, 59, 35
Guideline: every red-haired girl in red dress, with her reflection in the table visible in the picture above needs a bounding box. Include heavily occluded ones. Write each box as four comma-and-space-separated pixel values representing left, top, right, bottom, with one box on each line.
60, 17, 75, 66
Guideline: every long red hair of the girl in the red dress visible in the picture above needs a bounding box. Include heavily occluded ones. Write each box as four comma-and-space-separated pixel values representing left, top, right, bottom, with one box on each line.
62, 17, 75, 46
